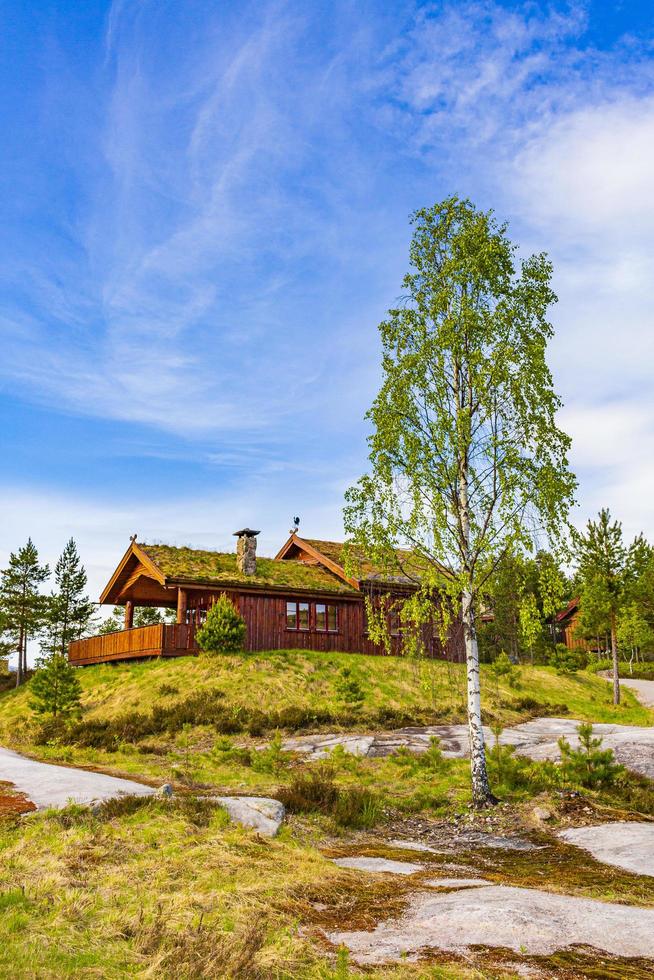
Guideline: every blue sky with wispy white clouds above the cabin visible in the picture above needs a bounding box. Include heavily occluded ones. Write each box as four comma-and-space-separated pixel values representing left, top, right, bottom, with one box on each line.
0, 0, 654, 620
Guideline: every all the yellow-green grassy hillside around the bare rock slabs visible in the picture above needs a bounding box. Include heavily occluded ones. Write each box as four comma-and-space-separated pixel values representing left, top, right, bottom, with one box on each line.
0, 651, 654, 980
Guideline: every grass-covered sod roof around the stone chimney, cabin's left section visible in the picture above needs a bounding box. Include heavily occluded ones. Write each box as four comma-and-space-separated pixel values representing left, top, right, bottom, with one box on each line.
138, 542, 357, 595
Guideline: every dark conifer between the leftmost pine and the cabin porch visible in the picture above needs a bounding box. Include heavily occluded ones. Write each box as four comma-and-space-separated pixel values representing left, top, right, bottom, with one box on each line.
42, 538, 94, 657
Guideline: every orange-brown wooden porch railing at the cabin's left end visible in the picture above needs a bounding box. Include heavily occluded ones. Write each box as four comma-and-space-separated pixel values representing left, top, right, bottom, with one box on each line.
68, 623, 198, 667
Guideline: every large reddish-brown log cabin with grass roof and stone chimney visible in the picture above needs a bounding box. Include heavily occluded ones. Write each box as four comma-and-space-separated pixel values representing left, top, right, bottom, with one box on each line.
68, 528, 464, 666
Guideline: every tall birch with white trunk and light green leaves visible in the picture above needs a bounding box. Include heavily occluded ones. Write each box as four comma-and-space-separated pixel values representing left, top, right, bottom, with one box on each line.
345, 197, 575, 807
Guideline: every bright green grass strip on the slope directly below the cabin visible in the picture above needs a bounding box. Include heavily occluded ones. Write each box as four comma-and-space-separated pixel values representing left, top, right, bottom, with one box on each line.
0, 650, 654, 731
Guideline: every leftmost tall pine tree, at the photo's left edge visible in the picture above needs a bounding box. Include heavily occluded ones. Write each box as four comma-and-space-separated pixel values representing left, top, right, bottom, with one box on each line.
0, 538, 50, 686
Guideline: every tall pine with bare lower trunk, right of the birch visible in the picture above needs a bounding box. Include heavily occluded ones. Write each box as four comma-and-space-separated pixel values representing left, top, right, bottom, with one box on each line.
573, 508, 647, 704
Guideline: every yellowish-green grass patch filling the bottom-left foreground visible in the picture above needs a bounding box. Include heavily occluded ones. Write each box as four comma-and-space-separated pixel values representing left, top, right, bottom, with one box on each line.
0, 801, 490, 980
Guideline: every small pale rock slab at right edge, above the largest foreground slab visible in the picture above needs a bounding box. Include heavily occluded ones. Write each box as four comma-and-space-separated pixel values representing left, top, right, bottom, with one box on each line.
560, 821, 654, 876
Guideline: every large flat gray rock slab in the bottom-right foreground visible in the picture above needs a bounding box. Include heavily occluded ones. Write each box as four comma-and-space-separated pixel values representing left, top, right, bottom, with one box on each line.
328, 885, 654, 964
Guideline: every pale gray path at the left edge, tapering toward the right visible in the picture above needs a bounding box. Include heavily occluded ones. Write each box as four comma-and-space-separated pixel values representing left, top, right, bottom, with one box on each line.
0, 748, 155, 810
